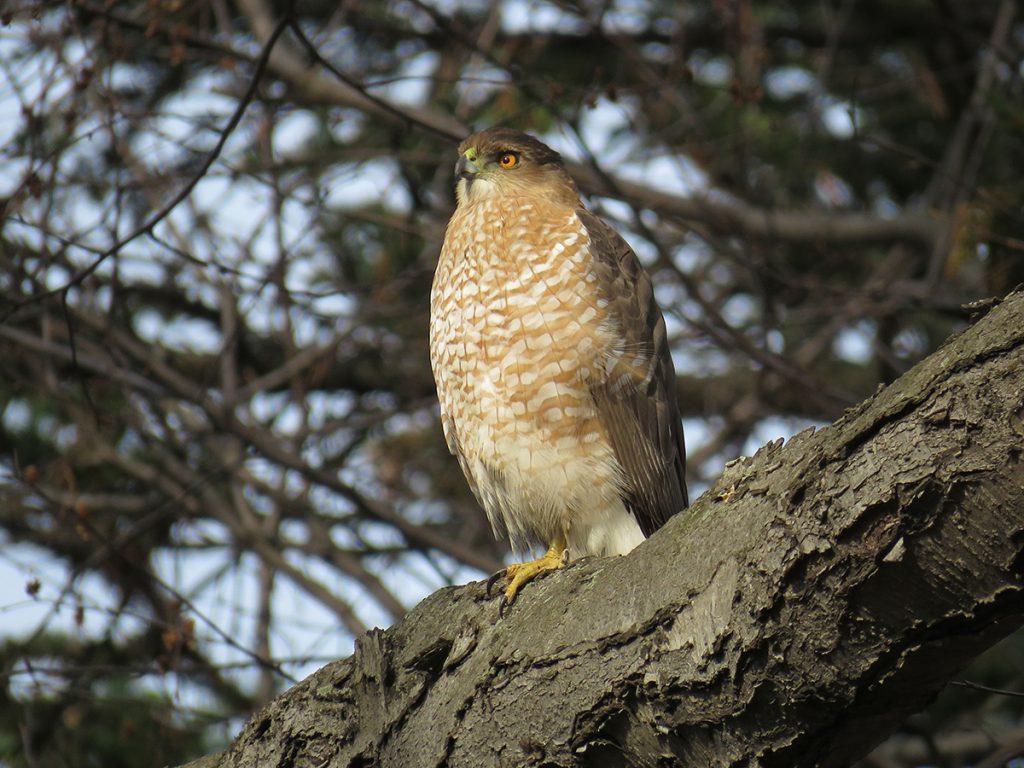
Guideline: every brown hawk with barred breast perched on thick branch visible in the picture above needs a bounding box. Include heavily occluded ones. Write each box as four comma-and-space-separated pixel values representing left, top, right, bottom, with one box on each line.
430, 128, 687, 609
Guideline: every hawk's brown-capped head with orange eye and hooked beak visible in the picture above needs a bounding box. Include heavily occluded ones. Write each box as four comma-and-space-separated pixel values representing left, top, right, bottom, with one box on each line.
455, 128, 580, 207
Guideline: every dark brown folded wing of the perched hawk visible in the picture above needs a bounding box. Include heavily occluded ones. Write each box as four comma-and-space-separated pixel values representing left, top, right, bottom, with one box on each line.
577, 209, 689, 536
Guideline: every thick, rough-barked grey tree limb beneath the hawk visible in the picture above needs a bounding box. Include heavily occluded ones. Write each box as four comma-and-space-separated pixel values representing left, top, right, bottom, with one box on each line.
184, 293, 1024, 768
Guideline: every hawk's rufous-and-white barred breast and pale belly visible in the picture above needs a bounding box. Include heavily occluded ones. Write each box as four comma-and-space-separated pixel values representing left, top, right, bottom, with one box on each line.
430, 199, 622, 543
